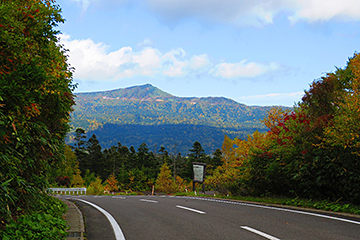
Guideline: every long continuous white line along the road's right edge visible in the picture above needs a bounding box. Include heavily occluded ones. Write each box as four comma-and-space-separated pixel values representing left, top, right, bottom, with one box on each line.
179, 197, 360, 225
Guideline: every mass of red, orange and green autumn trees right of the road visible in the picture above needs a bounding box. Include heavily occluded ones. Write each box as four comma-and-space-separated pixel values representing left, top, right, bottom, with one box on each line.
217, 54, 360, 205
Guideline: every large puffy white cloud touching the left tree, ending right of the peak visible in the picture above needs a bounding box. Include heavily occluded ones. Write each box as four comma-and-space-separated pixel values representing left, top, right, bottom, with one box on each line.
60, 35, 209, 81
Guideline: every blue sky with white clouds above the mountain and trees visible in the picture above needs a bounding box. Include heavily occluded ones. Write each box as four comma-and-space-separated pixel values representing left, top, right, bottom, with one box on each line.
57, 0, 360, 107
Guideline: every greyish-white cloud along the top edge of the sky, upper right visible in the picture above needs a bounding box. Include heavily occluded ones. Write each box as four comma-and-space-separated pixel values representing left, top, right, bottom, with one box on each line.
147, 0, 360, 25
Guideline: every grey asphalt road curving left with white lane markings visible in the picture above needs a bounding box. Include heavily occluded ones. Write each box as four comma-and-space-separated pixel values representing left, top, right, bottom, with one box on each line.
72, 196, 360, 240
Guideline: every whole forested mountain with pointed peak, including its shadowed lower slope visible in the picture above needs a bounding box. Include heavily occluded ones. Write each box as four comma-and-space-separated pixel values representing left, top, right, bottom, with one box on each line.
68, 84, 271, 154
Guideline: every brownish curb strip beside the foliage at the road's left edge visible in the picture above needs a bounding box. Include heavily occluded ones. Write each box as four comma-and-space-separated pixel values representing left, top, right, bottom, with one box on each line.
60, 199, 85, 240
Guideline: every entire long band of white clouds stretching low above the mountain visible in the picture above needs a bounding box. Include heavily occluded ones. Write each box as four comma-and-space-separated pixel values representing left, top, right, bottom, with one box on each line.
60, 35, 279, 81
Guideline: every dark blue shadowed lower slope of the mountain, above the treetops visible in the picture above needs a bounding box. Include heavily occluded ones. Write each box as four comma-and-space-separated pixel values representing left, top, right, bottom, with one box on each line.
87, 123, 256, 155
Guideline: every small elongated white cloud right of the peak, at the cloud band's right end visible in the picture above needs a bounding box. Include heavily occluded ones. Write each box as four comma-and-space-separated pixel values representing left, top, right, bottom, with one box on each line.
213, 60, 279, 78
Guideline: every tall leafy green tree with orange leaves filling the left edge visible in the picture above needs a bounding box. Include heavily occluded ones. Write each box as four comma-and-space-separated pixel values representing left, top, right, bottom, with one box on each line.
0, 0, 75, 227
